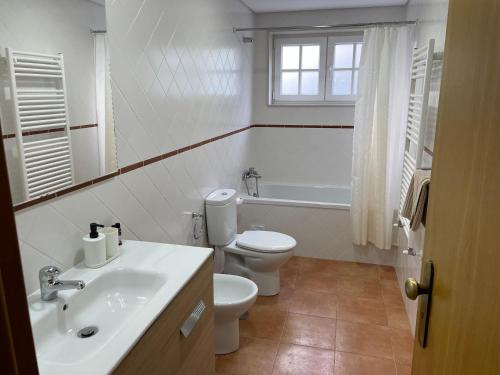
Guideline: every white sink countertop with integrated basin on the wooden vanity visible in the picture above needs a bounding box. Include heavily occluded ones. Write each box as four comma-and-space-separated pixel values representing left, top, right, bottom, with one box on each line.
28, 241, 212, 375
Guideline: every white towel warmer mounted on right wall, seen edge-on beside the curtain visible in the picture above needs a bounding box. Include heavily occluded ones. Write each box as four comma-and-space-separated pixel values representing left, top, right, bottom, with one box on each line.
399, 39, 442, 238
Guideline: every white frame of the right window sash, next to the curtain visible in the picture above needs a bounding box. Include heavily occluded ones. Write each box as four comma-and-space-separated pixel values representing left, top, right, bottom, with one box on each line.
325, 35, 363, 104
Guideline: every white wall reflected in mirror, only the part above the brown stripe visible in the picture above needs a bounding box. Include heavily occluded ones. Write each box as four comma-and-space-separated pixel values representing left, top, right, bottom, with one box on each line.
0, 0, 106, 129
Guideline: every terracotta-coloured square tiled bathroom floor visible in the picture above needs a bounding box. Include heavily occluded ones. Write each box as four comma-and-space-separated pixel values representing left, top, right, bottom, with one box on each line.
216, 257, 413, 375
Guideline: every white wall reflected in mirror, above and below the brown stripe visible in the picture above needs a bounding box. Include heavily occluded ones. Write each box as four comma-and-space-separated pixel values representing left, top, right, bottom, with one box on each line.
0, 0, 106, 203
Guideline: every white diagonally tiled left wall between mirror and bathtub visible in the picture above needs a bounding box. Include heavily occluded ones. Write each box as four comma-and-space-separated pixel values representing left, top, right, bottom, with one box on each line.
16, 0, 253, 292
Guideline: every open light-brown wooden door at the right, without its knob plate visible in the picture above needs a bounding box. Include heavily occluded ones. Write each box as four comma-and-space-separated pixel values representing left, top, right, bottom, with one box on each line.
413, 0, 500, 375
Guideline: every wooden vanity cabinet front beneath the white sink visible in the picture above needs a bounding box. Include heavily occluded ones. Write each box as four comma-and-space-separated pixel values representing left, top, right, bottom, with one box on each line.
114, 258, 215, 375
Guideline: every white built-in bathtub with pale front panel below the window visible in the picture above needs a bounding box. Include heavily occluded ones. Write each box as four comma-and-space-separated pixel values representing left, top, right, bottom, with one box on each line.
238, 182, 394, 265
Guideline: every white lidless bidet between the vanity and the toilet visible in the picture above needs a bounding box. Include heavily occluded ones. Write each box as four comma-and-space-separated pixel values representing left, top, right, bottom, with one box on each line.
214, 273, 257, 354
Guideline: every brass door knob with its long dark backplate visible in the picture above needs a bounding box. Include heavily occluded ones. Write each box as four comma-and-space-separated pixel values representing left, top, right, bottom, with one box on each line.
405, 261, 434, 348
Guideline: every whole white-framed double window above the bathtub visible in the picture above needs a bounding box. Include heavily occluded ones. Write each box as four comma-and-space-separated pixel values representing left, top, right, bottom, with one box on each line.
270, 35, 362, 105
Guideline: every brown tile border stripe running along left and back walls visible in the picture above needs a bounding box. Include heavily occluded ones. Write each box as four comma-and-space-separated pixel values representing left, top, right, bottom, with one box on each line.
14, 125, 353, 211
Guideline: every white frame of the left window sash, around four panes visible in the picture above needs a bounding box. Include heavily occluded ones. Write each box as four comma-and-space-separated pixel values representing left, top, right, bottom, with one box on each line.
273, 36, 328, 102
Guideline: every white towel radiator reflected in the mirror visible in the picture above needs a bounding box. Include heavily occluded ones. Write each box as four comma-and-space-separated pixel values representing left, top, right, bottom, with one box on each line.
6, 48, 74, 199
